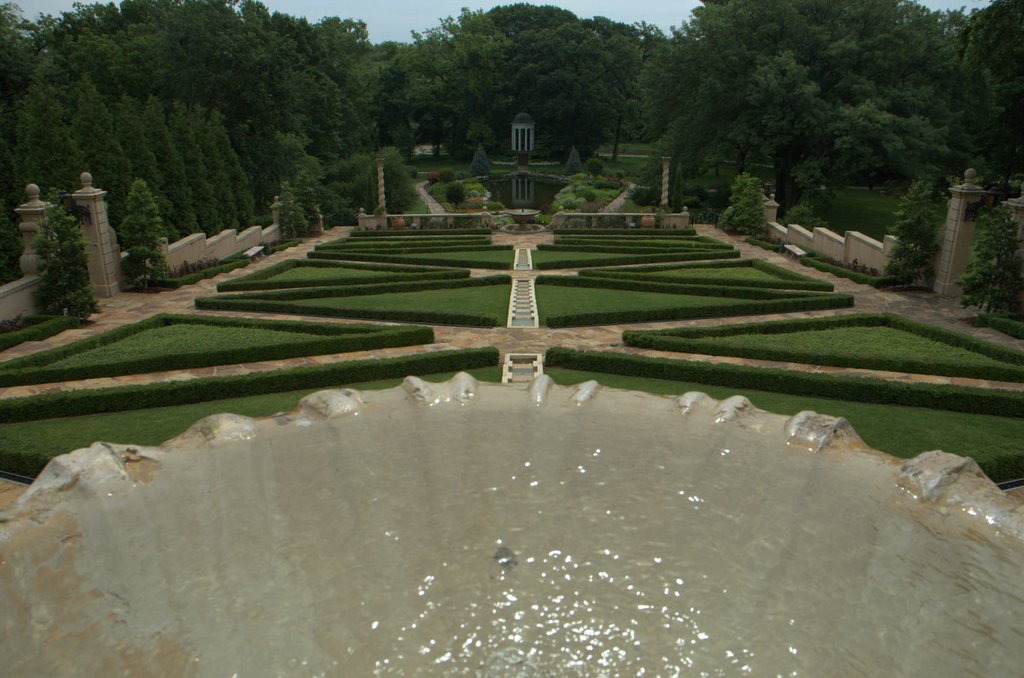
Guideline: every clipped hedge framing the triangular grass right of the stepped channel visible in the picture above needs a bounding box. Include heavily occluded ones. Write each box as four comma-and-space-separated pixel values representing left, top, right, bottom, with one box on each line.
537, 276, 853, 328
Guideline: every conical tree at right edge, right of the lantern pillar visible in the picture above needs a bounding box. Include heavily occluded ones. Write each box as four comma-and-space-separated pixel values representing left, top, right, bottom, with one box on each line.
956, 205, 1024, 312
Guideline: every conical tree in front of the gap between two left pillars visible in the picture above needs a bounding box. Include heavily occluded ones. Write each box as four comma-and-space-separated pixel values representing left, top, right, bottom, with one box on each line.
35, 200, 96, 320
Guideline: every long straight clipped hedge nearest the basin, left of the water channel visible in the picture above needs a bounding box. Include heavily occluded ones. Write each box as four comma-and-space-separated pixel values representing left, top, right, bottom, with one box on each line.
0, 347, 499, 422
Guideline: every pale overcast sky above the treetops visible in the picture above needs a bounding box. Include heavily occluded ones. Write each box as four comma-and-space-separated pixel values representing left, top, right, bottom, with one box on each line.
14, 0, 989, 42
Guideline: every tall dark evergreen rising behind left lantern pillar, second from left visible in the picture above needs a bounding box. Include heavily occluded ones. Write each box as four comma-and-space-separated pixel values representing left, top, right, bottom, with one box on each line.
72, 76, 131, 230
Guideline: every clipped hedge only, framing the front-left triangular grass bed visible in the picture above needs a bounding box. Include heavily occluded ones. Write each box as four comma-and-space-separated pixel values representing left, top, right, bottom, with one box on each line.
0, 314, 434, 386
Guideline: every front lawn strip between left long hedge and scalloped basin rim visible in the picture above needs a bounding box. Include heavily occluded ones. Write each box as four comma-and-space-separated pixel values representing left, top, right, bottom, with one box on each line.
0, 368, 501, 475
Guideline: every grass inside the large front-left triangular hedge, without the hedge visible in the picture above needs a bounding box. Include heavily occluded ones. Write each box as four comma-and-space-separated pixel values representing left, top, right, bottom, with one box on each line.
39, 323, 324, 368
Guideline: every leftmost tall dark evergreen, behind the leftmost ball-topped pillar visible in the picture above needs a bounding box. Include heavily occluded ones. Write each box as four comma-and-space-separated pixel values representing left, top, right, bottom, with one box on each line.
14, 79, 83, 197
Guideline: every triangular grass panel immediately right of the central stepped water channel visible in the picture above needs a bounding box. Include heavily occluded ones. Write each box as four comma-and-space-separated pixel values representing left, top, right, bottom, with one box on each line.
537, 285, 751, 325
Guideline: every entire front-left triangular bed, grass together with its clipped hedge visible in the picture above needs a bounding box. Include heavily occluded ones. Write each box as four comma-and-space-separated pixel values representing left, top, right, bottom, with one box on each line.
0, 314, 433, 386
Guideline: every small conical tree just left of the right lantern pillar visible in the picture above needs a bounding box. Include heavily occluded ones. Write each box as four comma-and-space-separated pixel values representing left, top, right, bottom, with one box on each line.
886, 179, 942, 285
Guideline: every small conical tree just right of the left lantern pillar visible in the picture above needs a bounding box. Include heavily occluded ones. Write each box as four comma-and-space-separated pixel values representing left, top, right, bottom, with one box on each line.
118, 179, 167, 289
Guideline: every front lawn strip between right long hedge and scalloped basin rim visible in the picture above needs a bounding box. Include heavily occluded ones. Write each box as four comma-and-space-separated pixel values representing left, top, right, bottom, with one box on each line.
545, 368, 1024, 481
